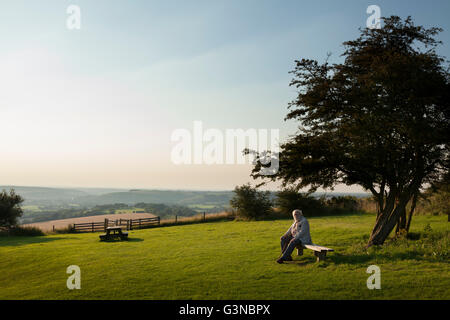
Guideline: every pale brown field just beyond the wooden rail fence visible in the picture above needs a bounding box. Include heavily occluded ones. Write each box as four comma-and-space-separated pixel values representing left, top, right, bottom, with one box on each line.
23, 213, 155, 232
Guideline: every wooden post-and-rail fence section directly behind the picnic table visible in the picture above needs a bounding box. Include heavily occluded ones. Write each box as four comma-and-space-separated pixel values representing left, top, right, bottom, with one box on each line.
72, 217, 161, 232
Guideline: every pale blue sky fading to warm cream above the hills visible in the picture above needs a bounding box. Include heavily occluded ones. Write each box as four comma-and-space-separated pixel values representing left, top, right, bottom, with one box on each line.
0, 0, 450, 191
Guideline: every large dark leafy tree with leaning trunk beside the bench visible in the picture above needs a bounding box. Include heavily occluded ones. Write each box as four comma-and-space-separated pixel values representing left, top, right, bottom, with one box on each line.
248, 16, 450, 246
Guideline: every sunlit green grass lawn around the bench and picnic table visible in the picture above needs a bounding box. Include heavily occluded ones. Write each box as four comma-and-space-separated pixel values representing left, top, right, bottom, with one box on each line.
0, 215, 450, 299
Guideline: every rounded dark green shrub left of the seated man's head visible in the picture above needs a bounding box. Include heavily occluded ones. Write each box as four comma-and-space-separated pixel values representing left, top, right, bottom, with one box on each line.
230, 184, 273, 220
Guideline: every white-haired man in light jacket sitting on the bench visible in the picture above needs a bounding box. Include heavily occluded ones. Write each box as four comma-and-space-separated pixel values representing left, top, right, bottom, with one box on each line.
277, 209, 312, 263
